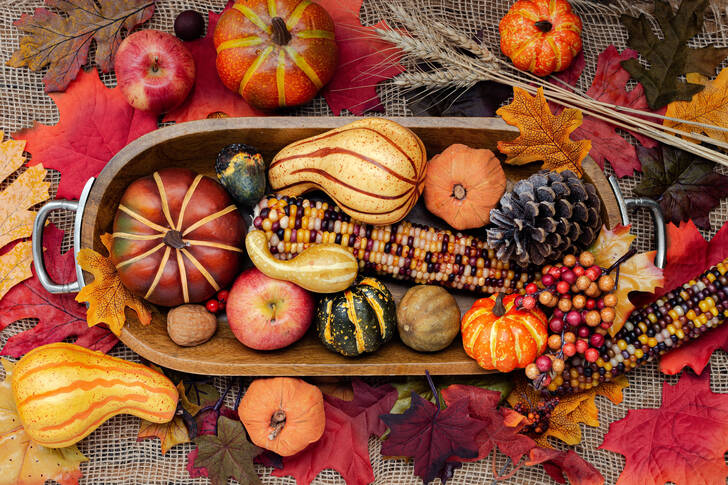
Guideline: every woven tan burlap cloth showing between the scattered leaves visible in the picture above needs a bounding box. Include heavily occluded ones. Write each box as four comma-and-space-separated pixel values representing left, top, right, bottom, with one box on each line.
0, 0, 728, 485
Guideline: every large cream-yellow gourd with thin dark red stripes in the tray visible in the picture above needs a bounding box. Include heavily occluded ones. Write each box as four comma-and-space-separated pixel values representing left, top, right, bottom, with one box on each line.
268, 118, 427, 224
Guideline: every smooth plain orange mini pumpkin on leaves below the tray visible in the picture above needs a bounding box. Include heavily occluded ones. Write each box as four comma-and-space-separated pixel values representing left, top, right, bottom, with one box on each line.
238, 377, 326, 456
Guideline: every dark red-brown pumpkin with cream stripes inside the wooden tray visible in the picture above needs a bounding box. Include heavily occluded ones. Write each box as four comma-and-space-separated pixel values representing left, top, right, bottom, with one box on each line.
111, 168, 246, 306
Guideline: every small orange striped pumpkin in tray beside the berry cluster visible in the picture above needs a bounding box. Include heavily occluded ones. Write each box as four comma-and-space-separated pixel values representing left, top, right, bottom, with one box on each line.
460, 293, 548, 372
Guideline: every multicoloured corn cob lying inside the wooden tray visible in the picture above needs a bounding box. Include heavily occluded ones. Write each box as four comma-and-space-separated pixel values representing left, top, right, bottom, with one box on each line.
253, 196, 536, 293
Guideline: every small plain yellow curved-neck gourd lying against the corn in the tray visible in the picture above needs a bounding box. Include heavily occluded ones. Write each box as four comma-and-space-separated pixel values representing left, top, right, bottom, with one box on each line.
245, 231, 359, 293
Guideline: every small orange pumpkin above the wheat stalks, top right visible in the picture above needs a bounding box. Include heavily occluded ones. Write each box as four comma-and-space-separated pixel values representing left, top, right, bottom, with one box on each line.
499, 0, 581, 76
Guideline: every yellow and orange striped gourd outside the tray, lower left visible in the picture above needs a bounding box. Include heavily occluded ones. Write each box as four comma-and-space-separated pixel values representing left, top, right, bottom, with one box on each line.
12, 343, 178, 448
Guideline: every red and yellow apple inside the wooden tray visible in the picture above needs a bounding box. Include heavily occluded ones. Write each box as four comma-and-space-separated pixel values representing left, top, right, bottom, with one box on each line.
225, 268, 314, 350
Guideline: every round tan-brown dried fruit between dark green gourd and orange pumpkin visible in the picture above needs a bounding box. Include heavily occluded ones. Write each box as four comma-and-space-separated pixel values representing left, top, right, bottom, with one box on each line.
397, 285, 460, 352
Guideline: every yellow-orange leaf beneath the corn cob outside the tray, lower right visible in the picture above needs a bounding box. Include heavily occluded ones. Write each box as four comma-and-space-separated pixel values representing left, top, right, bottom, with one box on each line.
507, 375, 629, 448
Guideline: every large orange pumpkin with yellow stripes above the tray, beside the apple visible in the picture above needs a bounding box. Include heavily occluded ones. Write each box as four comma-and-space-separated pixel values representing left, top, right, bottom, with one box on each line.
213, 0, 336, 109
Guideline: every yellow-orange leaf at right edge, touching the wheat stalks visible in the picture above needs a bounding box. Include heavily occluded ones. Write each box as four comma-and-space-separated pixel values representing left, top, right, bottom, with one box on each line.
663, 68, 728, 142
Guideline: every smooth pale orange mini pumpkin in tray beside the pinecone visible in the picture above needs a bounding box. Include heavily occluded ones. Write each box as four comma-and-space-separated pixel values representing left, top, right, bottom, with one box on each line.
424, 144, 506, 231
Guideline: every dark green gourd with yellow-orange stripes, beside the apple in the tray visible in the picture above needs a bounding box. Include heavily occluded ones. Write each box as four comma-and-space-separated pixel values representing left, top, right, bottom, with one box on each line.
315, 278, 397, 357
